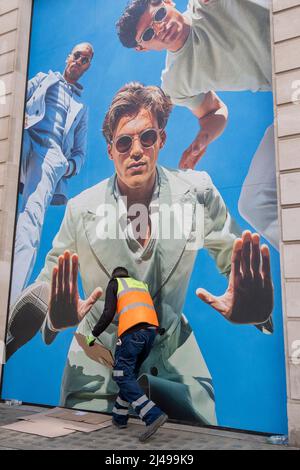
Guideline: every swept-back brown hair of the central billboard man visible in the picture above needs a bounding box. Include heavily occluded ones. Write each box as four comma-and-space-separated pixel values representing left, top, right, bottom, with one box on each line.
102, 82, 173, 144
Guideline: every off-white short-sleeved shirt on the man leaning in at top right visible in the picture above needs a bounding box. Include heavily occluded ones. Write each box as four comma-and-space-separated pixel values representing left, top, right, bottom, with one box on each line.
162, 0, 272, 109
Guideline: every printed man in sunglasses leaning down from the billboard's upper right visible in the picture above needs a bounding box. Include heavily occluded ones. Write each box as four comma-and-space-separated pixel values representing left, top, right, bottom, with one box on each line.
117, 0, 279, 249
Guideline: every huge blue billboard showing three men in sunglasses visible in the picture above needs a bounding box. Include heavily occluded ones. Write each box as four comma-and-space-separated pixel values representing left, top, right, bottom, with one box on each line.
2, 0, 287, 433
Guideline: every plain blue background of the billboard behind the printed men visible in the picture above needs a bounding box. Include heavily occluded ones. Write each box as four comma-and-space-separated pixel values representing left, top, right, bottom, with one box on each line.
2, 0, 287, 433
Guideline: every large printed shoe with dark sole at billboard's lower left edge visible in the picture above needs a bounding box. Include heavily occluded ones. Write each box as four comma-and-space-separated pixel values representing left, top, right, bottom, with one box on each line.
6, 282, 50, 360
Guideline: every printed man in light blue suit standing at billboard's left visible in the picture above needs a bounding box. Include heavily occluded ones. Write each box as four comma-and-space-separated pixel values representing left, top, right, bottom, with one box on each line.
11, 43, 94, 303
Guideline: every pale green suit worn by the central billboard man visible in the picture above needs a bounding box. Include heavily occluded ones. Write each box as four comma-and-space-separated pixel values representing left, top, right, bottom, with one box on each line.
37, 167, 240, 425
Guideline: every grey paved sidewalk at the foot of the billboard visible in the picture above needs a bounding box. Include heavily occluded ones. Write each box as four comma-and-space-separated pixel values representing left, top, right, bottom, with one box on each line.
0, 403, 300, 451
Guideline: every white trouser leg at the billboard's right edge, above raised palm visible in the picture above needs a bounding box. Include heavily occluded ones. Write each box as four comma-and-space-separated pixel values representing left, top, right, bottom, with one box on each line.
238, 125, 279, 250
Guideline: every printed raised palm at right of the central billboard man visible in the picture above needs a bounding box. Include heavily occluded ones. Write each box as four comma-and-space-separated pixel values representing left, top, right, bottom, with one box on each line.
196, 230, 273, 325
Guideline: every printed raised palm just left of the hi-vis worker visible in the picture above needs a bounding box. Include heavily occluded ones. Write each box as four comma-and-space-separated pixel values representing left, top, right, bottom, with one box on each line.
48, 251, 103, 330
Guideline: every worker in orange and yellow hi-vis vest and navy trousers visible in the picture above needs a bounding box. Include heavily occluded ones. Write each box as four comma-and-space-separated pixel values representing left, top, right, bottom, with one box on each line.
86, 267, 168, 442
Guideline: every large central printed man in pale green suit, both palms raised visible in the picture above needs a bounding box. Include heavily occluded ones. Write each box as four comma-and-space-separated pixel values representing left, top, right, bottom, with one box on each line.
7, 83, 273, 425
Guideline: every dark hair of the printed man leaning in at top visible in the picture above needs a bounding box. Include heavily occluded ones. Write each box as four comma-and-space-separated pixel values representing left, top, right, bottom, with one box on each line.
116, 0, 150, 48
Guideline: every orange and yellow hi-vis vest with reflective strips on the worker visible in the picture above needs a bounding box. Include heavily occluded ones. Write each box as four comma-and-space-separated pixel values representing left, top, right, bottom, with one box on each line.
114, 277, 159, 337
